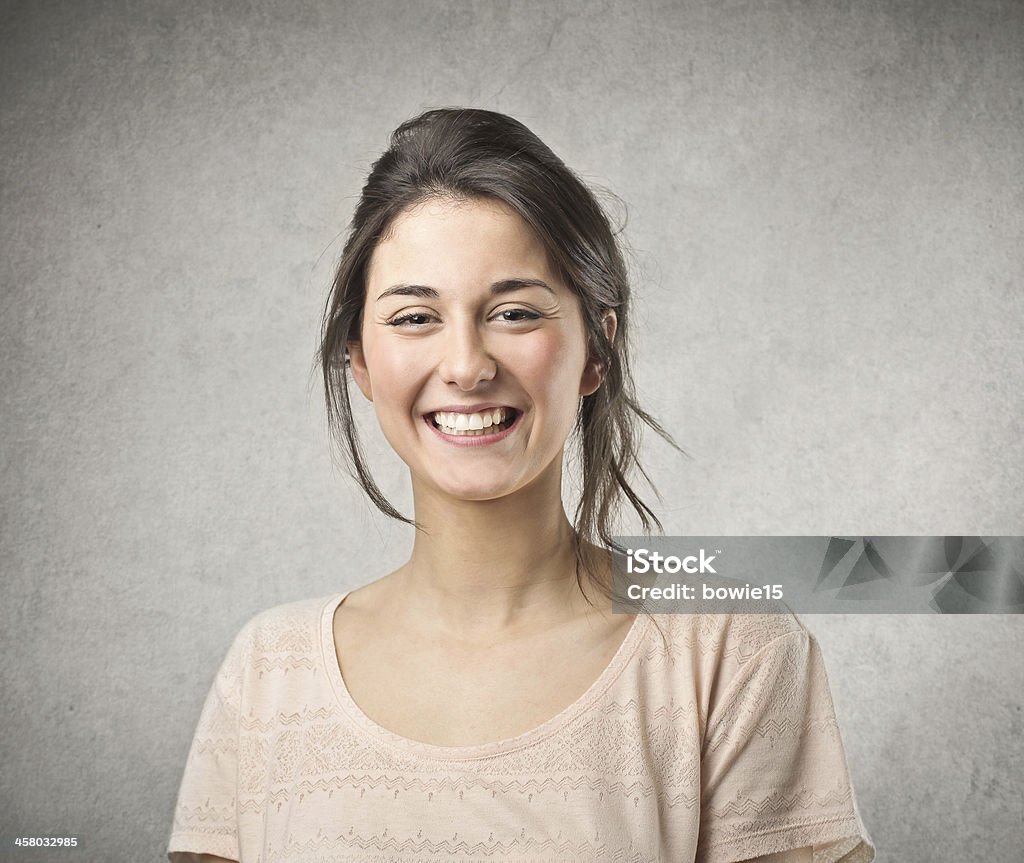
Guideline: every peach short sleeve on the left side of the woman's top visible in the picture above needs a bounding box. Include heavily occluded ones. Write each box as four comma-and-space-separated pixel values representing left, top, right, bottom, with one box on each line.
167, 627, 252, 860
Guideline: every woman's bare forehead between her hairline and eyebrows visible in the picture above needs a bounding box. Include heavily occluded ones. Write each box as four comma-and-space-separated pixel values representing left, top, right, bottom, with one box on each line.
368, 198, 558, 289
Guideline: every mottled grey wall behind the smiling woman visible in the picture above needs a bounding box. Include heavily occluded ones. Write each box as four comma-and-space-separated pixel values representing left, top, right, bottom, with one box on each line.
0, 0, 1024, 863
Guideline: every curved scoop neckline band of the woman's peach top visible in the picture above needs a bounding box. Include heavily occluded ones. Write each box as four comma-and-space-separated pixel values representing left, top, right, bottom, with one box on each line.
321, 591, 645, 762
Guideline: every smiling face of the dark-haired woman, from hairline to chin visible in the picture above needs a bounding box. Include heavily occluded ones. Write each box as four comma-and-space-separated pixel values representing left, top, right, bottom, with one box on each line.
349, 199, 600, 501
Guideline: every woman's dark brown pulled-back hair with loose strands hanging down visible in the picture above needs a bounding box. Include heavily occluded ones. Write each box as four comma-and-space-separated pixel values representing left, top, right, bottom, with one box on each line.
318, 109, 678, 593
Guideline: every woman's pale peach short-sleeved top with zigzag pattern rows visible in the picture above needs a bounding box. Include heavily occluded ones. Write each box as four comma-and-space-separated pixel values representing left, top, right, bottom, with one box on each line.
169, 595, 873, 863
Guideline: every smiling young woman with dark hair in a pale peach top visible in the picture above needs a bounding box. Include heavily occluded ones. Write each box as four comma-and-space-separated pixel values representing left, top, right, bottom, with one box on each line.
169, 110, 873, 863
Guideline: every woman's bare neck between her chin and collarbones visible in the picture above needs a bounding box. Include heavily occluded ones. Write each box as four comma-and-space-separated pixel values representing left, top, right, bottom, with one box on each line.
395, 472, 598, 633
